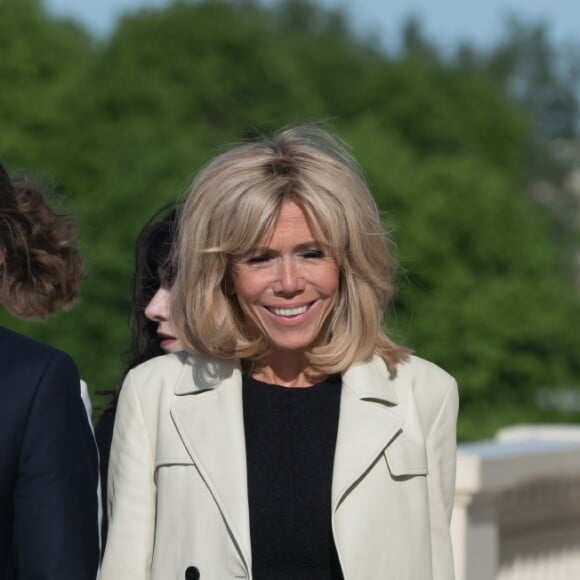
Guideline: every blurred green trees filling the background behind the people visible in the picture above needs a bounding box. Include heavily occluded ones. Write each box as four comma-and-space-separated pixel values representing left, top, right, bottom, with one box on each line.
0, 0, 580, 440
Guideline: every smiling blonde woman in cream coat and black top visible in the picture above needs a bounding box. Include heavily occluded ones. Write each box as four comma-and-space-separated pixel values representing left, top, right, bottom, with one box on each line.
102, 126, 458, 580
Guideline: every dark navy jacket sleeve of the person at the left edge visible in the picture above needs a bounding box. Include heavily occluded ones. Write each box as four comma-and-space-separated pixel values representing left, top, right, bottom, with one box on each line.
13, 352, 99, 580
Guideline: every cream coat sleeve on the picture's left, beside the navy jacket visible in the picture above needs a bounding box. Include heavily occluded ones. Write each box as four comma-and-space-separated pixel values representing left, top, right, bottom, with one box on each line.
99, 373, 156, 580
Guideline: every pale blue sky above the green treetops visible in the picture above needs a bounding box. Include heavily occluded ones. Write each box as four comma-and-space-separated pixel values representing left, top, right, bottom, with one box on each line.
44, 0, 580, 47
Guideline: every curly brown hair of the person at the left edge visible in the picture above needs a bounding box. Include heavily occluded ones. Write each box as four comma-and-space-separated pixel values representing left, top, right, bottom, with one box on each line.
0, 164, 84, 318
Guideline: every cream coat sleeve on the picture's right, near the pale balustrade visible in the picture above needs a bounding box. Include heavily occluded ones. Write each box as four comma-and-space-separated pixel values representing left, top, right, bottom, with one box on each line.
426, 379, 459, 580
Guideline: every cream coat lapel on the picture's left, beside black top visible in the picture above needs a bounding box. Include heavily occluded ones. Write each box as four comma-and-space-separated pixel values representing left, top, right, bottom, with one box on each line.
171, 356, 251, 574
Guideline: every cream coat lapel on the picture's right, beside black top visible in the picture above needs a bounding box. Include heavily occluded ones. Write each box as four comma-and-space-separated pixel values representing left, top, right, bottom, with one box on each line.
332, 357, 404, 512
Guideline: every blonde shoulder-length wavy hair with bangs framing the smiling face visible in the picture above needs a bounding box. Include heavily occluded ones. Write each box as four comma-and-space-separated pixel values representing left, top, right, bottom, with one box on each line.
172, 125, 409, 374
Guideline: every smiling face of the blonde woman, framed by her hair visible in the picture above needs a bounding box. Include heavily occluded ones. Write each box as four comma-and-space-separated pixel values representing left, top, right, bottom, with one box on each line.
232, 201, 339, 355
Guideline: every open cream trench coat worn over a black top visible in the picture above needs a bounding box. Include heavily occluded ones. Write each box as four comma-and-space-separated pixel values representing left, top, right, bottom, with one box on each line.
100, 353, 458, 580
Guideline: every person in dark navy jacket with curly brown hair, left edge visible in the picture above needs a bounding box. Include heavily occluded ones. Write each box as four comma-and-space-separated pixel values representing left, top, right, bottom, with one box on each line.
0, 165, 99, 580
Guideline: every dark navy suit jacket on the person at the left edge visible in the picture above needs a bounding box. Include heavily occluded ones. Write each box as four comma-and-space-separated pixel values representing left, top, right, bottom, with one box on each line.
0, 327, 99, 580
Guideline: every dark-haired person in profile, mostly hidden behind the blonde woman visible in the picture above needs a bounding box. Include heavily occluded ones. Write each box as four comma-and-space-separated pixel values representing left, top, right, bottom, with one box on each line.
95, 209, 182, 548
